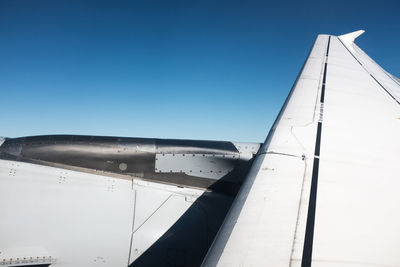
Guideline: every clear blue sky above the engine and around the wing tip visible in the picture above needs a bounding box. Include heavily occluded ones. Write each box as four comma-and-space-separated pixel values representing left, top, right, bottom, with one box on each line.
0, 0, 400, 142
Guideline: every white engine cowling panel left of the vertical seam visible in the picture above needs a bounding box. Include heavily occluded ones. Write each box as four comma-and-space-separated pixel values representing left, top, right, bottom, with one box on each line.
0, 160, 133, 266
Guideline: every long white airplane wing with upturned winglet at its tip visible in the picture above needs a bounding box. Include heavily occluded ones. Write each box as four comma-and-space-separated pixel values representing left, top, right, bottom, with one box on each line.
203, 31, 400, 266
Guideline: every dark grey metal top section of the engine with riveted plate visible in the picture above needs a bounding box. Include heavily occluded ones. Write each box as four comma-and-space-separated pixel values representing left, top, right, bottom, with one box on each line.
0, 135, 260, 194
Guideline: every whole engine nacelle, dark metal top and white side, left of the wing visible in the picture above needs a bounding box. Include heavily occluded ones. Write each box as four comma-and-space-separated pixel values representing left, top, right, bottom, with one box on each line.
0, 135, 260, 267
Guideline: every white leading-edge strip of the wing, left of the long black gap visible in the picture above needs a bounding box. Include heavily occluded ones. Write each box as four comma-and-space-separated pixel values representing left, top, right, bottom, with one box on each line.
203, 35, 328, 266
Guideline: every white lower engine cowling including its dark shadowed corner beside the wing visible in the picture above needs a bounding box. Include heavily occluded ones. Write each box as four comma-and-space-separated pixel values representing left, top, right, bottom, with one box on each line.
0, 160, 233, 267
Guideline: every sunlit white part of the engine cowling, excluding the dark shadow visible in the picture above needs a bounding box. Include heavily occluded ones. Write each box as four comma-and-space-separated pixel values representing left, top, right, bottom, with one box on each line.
0, 160, 203, 267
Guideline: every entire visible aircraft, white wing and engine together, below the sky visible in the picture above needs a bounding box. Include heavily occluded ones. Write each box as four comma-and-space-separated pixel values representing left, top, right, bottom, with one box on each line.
0, 31, 400, 267
